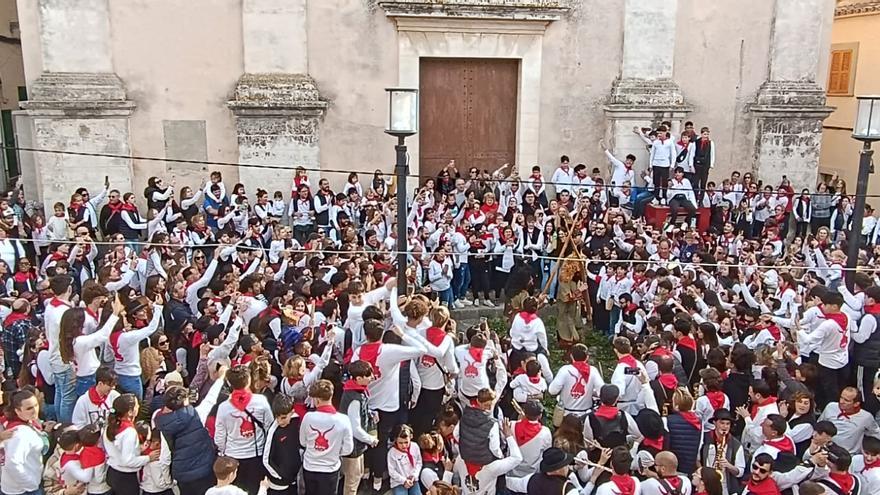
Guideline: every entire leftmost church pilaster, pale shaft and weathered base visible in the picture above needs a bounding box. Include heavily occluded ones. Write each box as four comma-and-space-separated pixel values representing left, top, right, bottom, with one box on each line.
22, 0, 135, 211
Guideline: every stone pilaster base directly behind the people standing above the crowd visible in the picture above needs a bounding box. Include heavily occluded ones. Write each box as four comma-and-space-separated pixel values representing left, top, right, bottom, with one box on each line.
604, 79, 692, 184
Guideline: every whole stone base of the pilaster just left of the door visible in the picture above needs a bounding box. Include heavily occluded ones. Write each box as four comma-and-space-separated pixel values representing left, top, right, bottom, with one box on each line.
228, 74, 327, 190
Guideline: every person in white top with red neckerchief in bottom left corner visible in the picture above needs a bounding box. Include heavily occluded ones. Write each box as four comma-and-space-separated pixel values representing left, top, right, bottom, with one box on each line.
0, 390, 47, 495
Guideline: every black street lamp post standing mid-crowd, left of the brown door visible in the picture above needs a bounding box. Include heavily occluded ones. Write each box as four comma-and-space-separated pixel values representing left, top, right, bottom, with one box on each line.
385, 88, 419, 294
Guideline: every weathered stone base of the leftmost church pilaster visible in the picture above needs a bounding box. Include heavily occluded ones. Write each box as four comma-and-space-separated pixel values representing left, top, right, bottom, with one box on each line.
19, 73, 135, 208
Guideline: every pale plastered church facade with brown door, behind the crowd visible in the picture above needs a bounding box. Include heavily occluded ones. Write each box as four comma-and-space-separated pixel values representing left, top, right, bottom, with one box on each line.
16, 0, 835, 208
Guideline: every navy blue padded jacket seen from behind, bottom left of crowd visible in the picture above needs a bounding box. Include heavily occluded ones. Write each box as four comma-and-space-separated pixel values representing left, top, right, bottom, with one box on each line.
156, 406, 216, 483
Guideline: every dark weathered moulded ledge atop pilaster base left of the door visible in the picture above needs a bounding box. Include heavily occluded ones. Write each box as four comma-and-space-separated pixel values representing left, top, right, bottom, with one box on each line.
227, 74, 328, 116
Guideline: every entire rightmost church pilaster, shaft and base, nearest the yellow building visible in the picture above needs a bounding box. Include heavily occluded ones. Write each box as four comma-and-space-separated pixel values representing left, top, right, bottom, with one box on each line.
749, 0, 834, 189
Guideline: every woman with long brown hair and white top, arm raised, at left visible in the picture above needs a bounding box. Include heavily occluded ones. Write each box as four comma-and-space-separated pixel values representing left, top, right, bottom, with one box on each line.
59, 297, 125, 397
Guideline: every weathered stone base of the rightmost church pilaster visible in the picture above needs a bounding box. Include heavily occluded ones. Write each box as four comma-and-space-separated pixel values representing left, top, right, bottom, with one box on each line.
748, 81, 834, 190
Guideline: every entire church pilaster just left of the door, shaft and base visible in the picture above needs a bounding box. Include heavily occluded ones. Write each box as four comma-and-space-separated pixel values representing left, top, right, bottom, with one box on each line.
228, 0, 327, 190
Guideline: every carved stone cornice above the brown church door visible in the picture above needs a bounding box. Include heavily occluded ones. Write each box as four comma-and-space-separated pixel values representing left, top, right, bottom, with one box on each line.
379, 0, 569, 21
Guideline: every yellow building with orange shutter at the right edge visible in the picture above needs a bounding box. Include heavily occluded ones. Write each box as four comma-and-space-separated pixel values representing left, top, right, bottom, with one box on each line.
819, 0, 880, 198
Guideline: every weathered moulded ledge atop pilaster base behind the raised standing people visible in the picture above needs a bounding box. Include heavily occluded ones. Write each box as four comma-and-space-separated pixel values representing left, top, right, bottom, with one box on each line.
605, 78, 692, 112
